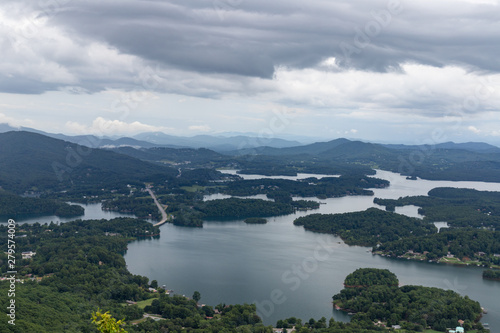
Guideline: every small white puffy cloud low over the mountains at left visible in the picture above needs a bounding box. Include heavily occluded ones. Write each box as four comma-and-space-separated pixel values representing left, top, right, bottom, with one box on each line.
66, 117, 166, 136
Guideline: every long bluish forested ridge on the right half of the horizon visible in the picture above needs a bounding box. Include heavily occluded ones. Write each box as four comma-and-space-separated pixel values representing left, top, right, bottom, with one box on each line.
232, 139, 500, 182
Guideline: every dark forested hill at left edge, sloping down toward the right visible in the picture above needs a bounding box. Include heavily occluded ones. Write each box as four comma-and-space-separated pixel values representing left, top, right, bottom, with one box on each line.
0, 131, 177, 192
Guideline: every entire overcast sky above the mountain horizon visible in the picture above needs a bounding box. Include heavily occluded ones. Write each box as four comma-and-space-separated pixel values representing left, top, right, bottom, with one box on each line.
0, 0, 500, 145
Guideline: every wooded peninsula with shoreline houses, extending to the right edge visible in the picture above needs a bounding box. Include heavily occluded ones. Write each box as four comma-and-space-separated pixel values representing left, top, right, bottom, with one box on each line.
294, 208, 500, 267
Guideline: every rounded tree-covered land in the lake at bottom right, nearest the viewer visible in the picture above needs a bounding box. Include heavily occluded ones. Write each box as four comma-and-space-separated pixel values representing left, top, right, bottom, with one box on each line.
333, 268, 482, 332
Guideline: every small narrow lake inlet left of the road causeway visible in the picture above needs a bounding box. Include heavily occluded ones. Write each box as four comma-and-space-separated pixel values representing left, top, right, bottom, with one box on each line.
9, 202, 139, 224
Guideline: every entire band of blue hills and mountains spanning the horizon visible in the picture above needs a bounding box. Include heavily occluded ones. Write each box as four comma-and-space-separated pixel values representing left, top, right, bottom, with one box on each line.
0, 125, 500, 190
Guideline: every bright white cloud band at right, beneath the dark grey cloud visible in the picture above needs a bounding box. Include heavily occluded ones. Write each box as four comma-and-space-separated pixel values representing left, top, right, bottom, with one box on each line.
274, 63, 500, 117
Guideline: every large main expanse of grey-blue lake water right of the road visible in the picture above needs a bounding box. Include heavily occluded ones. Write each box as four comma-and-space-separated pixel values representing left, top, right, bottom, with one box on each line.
125, 171, 500, 326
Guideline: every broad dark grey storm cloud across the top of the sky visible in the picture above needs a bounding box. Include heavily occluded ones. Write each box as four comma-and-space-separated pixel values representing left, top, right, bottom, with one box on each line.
42, 0, 500, 78
